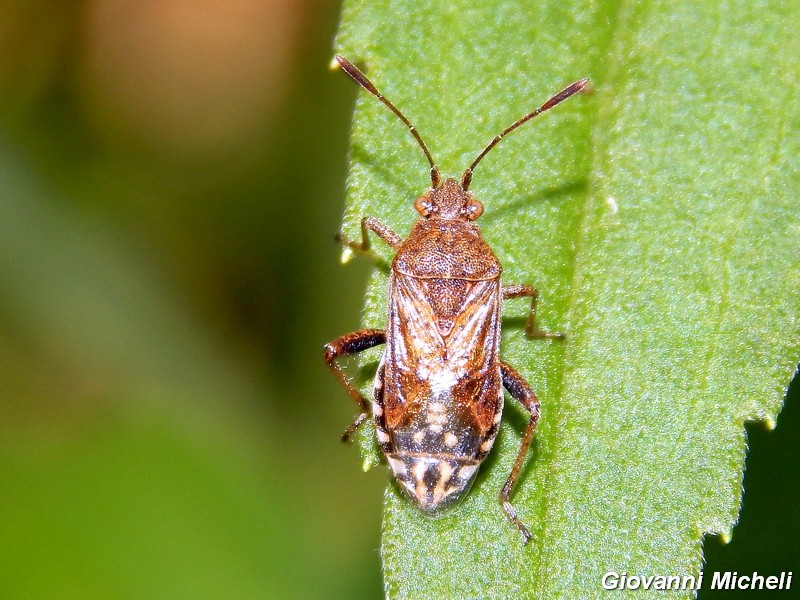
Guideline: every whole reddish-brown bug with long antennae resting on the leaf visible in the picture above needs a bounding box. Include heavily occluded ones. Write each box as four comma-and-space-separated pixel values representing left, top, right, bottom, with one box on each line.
325, 55, 588, 543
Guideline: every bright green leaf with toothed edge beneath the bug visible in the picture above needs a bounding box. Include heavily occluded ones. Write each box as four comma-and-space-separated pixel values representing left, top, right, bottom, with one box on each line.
336, 0, 800, 598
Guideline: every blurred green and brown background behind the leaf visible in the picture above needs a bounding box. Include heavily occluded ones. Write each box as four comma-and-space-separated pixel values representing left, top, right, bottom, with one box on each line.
0, 0, 800, 599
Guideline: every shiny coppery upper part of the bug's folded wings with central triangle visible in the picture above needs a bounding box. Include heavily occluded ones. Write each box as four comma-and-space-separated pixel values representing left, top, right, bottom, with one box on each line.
383, 275, 501, 431
